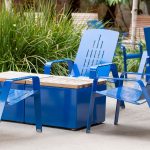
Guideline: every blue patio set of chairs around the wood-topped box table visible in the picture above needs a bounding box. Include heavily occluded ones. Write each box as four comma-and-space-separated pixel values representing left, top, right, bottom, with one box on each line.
0, 27, 150, 132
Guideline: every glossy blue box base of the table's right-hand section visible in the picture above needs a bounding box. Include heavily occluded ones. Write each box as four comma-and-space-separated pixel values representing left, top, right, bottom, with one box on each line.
25, 85, 106, 129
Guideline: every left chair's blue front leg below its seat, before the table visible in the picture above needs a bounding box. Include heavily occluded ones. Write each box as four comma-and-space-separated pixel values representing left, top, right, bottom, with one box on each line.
34, 92, 42, 132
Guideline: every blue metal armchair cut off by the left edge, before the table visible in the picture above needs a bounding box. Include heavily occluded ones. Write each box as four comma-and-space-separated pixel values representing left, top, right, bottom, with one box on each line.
0, 76, 42, 132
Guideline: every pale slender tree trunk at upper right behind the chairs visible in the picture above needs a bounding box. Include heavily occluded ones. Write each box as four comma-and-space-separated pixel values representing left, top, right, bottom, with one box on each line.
131, 0, 138, 43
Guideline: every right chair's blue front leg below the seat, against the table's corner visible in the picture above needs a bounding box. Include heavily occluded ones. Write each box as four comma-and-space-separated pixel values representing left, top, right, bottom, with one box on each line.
86, 95, 95, 133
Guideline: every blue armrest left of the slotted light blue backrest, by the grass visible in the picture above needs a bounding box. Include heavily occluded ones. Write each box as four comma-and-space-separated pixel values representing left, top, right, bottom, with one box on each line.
44, 58, 74, 74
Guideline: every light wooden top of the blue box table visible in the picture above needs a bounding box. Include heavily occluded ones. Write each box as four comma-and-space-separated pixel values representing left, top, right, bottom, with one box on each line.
0, 71, 105, 89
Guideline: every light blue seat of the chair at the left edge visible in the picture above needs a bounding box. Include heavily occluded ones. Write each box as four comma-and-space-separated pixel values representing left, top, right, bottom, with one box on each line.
7, 89, 37, 105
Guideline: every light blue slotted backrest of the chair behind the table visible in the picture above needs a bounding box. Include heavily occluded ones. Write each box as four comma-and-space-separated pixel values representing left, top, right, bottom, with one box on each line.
71, 29, 119, 76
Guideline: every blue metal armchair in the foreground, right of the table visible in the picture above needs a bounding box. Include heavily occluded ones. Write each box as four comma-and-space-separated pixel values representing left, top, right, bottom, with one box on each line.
86, 51, 150, 133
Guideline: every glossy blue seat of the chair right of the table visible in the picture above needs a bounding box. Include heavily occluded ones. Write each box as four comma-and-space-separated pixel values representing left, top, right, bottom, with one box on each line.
96, 87, 146, 105
